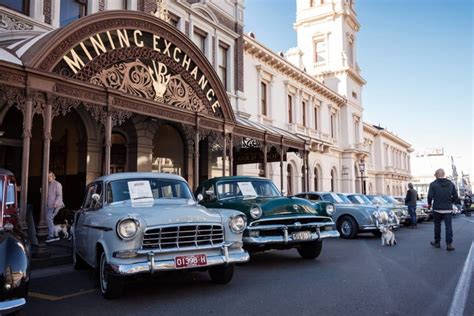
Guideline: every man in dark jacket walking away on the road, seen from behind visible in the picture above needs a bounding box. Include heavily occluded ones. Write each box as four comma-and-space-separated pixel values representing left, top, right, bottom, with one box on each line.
428, 169, 458, 251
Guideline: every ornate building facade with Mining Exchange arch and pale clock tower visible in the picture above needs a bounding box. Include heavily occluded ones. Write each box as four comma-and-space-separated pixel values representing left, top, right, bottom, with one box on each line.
0, 0, 410, 244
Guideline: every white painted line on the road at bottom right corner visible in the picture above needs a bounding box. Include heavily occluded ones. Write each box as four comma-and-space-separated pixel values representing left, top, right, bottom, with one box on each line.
448, 241, 474, 316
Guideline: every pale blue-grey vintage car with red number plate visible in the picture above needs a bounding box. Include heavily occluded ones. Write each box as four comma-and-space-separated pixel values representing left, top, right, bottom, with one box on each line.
73, 173, 249, 298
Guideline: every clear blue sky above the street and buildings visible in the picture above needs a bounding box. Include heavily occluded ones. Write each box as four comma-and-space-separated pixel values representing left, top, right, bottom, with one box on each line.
244, 0, 474, 180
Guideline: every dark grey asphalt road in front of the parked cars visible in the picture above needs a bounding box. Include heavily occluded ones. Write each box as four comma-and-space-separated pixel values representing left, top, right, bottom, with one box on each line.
23, 215, 474, 316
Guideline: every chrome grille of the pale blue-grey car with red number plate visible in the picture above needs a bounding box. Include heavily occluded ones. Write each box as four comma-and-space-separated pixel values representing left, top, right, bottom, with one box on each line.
142, 225, 224, 249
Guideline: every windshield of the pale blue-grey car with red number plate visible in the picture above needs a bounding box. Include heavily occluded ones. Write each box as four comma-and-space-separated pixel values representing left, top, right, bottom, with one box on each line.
107, 178, 193, 203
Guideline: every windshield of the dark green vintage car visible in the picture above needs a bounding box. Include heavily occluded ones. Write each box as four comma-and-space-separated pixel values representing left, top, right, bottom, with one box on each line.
217, 180, 281, 200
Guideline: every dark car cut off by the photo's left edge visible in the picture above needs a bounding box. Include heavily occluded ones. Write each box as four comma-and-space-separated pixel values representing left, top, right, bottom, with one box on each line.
0, 168, 30, 315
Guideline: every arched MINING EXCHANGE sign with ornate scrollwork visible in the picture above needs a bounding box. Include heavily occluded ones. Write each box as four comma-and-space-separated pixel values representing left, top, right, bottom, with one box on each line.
56, 29, 221, 113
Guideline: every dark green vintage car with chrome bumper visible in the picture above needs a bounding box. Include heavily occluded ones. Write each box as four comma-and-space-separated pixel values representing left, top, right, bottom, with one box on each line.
196, 176, 339, 259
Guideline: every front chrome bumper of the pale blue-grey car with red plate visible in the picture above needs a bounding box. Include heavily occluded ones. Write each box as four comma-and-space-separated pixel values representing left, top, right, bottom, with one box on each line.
110, 245, 250, 276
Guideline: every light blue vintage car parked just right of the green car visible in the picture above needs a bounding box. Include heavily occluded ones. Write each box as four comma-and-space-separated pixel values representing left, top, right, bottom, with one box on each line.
295, 192, 399, 239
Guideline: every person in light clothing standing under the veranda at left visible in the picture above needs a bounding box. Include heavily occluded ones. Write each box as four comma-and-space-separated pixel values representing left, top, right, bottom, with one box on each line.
46, 171, 64, 242
